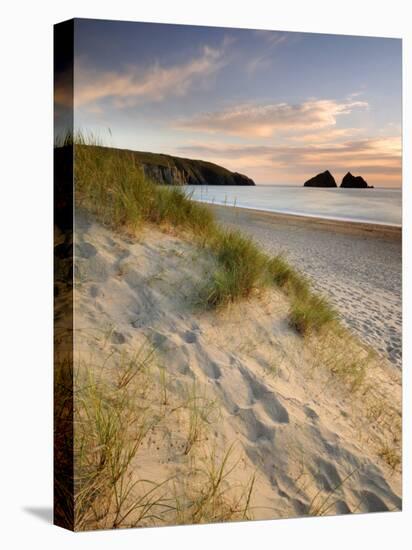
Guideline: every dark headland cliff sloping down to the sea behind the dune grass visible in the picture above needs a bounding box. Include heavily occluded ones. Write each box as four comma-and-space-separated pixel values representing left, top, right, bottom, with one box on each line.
82, 146, 255, 185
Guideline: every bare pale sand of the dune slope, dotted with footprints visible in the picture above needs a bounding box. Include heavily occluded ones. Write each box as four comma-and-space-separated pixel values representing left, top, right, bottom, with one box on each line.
75, 212, 401, 523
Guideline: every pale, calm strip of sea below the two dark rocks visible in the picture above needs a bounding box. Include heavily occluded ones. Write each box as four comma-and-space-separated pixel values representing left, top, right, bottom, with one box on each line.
184, 185, 402, 226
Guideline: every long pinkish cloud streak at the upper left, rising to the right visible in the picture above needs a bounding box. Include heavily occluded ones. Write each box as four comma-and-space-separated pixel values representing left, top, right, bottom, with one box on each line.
74, 46, 224, 108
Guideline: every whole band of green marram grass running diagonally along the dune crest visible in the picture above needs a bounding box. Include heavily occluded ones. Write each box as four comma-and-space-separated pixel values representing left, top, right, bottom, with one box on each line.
69, 133, 336, 334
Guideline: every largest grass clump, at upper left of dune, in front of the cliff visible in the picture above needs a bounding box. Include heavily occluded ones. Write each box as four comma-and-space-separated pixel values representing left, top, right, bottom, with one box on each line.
74, 142, 214, 234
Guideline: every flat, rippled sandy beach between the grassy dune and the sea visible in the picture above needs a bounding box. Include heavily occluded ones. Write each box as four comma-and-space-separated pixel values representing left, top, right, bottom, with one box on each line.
212, 206, 402, 367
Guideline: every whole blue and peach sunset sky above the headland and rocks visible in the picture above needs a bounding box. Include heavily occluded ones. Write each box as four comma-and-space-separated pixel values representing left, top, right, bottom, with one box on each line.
66, 19, 402, 187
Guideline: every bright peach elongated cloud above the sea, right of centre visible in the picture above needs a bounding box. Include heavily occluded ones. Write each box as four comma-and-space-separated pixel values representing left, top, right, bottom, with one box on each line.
177, 99, 368, 137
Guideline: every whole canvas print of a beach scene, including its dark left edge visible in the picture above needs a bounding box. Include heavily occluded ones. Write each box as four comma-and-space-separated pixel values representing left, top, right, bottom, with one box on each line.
54, 19, 402, 531
